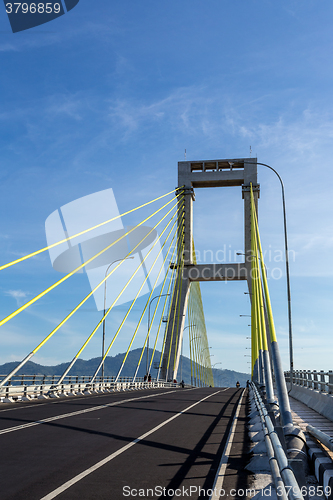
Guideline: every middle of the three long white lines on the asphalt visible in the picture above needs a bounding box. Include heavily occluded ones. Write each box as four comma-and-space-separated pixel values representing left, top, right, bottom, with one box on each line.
41, 389, 226, 500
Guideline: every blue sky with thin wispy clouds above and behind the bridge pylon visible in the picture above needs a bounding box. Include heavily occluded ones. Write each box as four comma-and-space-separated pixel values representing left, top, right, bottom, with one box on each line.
0, 0, 333, 371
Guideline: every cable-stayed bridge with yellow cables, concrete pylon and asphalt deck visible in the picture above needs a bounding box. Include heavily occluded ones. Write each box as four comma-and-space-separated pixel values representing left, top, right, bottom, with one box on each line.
0, 158, 333, 500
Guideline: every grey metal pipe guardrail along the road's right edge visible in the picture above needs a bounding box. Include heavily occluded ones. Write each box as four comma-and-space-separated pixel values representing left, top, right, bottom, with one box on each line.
251, 382, 304, 500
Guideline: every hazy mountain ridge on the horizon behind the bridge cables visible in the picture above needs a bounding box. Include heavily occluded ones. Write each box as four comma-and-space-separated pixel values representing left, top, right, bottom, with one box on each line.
0, 349, 251, 387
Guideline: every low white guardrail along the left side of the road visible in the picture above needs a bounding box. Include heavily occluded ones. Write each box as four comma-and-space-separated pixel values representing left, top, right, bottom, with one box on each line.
0, 375, 178, 402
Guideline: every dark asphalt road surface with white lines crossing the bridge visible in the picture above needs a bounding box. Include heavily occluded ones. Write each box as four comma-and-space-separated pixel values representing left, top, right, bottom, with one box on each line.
0, 388, 247, 500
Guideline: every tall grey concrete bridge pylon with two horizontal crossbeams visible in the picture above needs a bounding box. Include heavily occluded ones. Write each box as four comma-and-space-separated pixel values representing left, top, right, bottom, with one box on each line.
160, 158, 260, 380
